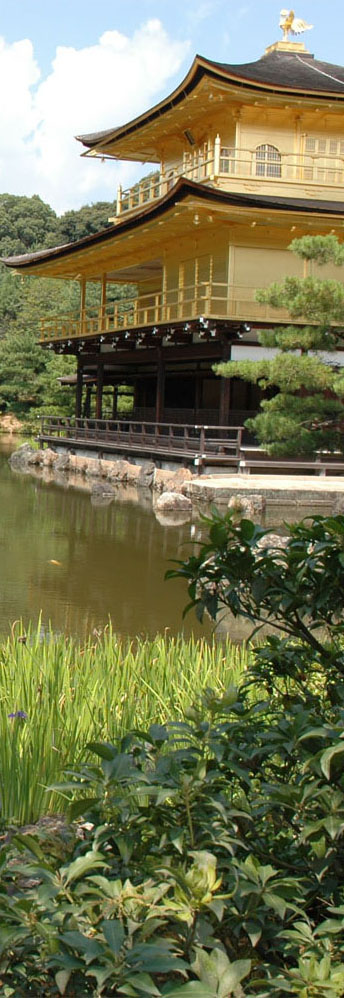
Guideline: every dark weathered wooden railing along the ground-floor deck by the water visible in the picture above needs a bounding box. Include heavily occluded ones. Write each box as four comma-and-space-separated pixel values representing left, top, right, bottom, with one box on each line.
39, 416, 243, 466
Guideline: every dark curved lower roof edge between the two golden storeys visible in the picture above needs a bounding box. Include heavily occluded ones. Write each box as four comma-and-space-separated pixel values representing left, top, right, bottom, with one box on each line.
2, 177, 344, 279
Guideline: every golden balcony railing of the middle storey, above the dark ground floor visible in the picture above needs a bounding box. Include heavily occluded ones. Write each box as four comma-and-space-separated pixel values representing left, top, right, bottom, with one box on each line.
40, 281, 290, 343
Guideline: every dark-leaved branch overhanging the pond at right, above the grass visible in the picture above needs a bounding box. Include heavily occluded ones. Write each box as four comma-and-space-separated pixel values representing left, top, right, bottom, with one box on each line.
167, 510, 344, 674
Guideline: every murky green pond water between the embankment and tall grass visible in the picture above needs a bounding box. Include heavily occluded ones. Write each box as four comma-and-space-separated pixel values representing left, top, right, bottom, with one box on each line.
0, 437, 334, 640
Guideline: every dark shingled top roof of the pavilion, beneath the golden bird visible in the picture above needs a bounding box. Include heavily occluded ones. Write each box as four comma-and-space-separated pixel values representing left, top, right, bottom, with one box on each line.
76, 49, 344, 148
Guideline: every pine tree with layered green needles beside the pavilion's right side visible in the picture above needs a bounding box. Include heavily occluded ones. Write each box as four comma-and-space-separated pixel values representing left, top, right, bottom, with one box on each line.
216, 235, 344, 456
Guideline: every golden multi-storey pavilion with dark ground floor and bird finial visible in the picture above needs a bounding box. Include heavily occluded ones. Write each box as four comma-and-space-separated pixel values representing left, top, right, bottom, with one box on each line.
6, 12, 344, 468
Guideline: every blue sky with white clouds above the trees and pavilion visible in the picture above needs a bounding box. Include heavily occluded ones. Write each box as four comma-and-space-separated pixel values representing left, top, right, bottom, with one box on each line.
0, 0, 344, 214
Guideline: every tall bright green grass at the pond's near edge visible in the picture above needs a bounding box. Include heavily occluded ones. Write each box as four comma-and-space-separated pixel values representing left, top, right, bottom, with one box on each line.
0, 627, 249, 825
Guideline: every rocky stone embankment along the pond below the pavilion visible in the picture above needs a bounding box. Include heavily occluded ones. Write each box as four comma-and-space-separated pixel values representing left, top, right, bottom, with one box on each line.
10, 444, 344, 526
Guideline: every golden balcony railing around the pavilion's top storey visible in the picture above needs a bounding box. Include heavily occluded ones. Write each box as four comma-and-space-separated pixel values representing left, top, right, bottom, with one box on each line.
114, 136, 344, 220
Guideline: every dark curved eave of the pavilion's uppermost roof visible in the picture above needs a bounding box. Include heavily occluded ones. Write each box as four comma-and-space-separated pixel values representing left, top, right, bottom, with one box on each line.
75, 55, 344, 153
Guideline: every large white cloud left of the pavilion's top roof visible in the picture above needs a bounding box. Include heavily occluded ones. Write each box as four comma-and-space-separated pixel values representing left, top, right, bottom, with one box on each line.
0, 20, 189, 212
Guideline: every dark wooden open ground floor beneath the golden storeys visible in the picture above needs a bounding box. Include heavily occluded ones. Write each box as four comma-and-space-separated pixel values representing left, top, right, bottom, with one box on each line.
75, 343, 260, 426
